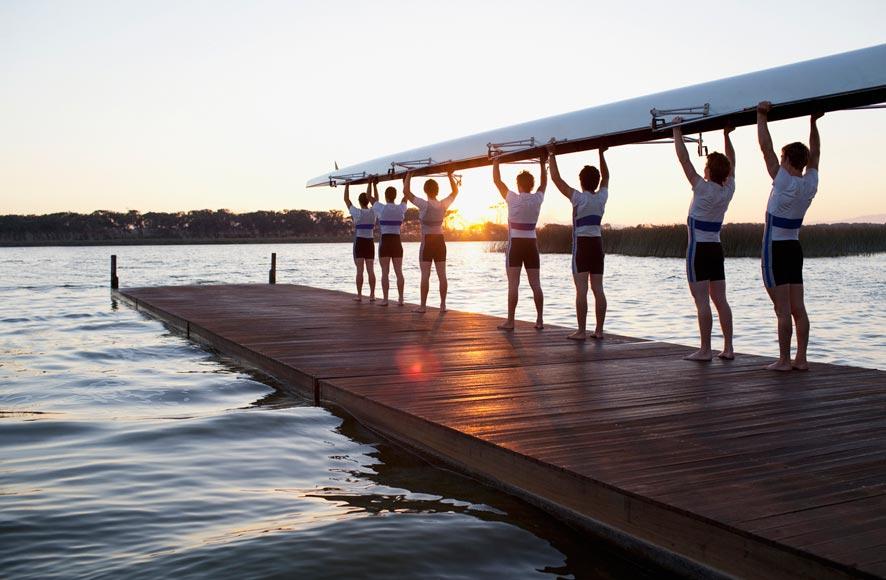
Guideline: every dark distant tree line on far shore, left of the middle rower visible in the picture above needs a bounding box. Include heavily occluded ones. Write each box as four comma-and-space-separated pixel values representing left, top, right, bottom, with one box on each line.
0, 208, 507, 245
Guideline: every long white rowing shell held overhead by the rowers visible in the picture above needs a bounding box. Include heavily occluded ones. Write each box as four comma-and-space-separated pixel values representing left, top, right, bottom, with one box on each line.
307, 44, 886, 187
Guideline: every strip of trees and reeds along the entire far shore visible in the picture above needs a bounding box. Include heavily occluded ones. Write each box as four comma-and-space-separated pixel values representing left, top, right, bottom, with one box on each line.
0, 208, 886, 258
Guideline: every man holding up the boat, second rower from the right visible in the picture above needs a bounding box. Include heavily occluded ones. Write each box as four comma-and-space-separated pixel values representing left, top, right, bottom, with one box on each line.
673, 117, 735, 361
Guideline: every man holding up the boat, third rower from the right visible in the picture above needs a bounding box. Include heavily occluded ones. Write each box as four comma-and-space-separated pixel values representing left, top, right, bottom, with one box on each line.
548, 143, 609, 340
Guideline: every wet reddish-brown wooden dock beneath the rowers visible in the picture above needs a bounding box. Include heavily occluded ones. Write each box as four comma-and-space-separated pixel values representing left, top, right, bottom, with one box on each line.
115, 285, 886, 578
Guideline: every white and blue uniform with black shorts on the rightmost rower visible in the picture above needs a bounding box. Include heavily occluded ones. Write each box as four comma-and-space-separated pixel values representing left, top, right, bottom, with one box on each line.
762, 167, 818, 288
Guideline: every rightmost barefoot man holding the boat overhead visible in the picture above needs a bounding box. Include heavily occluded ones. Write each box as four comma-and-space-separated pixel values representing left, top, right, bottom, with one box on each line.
757, 101, 824, 371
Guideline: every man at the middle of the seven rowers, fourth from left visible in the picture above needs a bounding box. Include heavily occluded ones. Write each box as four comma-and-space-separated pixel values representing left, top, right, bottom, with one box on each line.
492, 152, 548, 330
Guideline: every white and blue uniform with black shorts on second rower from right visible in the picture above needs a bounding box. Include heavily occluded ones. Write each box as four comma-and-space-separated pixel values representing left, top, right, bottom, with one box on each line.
686, 175, 735, 282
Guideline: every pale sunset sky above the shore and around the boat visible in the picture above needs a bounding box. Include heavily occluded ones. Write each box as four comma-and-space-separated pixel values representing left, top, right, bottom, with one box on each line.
0, 0, 886, 225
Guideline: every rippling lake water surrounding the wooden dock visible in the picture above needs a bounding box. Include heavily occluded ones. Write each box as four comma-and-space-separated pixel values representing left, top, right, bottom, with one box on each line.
0, 244, 886, 578
